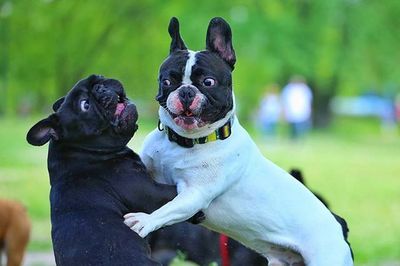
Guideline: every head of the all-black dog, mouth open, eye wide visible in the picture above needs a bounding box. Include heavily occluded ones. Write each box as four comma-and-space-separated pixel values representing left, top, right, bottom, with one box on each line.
27, 75, 138, 150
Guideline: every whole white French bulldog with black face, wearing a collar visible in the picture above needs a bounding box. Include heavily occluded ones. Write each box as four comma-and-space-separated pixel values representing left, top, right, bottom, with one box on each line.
125, 18, 353, 266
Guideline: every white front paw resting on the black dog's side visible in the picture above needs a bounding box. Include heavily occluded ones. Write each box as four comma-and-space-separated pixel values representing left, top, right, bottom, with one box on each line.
124, 212, 156, 238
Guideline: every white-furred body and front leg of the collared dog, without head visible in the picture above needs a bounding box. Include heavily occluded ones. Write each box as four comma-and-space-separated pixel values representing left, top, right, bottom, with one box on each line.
125, 96, 353, 266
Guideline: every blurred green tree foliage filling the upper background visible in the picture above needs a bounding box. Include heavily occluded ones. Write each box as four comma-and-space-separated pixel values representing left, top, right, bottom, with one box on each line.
0, 0, 400, 118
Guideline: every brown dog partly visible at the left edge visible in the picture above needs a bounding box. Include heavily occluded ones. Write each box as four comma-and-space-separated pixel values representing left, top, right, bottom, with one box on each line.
0, 199, 31, 266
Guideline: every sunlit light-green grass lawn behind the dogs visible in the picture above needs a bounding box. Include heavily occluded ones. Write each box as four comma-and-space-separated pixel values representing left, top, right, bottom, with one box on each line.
0, 115, 400, 265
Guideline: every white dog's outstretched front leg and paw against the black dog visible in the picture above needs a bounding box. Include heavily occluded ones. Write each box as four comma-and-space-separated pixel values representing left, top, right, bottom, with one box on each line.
124, 189, 206, 237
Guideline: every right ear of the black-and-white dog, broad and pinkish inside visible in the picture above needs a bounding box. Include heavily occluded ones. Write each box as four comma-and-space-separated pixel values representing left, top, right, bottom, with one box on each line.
206, 17, 236, 69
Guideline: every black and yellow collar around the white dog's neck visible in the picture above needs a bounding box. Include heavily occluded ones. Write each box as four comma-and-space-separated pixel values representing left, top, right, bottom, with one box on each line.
158, 116, 233, 148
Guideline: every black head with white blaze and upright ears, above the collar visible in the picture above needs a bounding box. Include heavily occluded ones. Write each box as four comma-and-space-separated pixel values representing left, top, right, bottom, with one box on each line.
156, 18, 235, 132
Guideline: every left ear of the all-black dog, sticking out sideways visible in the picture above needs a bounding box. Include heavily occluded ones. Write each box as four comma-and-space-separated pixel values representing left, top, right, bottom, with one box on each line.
26, 115, 59, 146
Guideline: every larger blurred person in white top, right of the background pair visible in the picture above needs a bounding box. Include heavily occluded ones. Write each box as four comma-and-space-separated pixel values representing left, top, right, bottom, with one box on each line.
281, 76, 313, 139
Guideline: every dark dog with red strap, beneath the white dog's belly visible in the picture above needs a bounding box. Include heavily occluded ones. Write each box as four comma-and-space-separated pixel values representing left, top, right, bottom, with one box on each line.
148, 223, 268, 266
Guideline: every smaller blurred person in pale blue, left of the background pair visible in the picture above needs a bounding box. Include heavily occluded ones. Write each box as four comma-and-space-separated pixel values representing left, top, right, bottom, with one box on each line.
257, 84, 281, 136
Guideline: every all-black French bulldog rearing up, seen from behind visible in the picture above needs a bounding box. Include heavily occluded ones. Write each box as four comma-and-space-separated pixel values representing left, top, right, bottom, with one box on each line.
27, 75, 176, 266
